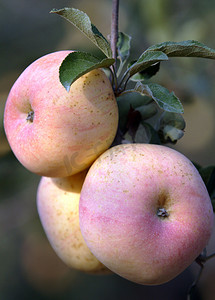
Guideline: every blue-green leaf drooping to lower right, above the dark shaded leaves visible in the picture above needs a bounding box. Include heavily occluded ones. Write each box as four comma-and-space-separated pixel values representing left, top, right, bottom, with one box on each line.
134, 82, 184, 113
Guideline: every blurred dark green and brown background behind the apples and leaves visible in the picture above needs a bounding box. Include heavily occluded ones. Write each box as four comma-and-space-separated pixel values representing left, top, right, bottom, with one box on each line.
0, 0, 215, 300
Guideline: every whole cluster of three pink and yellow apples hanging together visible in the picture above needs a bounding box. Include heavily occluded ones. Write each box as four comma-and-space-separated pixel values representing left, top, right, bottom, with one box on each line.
4, 51, 214, 285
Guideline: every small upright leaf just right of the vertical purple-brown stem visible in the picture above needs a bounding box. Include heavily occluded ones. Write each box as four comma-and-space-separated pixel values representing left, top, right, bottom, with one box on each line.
117, 32, 131, 63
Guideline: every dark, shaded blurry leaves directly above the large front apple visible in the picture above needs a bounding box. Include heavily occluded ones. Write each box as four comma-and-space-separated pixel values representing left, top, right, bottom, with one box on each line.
118, 94, 185, 145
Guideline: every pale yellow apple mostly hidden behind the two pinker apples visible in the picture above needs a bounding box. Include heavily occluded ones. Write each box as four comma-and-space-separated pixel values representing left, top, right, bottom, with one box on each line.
37, 171, 110, 274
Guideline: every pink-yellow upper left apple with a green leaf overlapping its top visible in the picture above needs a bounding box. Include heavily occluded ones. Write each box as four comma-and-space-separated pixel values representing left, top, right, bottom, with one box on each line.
4, 51, 118, 177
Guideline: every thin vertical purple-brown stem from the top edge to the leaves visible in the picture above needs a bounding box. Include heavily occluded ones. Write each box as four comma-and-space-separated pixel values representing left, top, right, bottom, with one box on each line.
111, 0, 119, 91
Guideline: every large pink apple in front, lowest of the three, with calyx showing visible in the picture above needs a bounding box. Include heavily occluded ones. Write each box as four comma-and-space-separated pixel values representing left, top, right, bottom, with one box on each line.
79, 144, 214, 285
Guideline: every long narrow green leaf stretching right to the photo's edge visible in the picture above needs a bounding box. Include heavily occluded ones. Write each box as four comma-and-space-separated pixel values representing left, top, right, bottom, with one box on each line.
145, 40, 215, 59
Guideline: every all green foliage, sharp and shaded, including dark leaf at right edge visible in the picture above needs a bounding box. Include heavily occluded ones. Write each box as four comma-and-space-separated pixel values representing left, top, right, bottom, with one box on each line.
51, 8, 215, 211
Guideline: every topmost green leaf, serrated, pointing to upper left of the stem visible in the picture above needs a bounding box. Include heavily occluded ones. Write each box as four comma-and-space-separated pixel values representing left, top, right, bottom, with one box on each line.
50, 7, 112, 58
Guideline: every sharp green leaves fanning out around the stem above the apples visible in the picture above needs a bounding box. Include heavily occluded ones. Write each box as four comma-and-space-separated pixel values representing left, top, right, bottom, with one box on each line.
51, 8, 215, 113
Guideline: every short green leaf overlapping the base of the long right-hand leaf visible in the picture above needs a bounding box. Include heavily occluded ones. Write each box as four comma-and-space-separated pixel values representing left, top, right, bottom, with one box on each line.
129, 51, 168, 77
